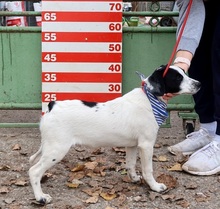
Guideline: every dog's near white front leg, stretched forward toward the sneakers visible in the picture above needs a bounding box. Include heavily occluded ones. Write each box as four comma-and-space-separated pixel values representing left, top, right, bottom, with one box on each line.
139, 142, 167, 192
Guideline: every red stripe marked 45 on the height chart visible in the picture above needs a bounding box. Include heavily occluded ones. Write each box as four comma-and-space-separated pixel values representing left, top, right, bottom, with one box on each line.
42, 52, 122, 62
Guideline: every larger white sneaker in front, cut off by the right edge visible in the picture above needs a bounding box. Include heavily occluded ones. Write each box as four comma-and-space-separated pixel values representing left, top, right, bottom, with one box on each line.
182, 141, 220, 176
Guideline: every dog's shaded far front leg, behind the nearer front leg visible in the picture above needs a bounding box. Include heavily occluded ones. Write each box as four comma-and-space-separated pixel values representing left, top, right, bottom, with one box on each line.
126, 147, 140, 182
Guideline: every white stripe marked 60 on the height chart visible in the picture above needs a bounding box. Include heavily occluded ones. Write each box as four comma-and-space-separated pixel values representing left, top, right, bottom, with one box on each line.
42, 22, 122, 33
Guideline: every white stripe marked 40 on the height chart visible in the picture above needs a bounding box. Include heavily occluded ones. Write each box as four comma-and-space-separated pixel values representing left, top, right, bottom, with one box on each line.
42, 62, 122, 73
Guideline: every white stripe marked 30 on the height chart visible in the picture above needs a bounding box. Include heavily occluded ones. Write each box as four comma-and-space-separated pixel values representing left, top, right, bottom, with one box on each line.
42, 82, 121, 93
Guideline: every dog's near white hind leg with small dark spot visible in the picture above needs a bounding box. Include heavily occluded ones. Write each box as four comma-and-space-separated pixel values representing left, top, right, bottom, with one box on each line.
29, 140, 71, 204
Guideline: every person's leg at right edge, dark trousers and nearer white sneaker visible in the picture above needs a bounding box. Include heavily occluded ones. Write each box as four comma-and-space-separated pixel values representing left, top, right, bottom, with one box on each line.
182, 8, 220, 175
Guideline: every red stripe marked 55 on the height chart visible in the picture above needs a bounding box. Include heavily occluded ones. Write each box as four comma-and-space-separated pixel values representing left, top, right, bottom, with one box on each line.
42, 32, 122, 42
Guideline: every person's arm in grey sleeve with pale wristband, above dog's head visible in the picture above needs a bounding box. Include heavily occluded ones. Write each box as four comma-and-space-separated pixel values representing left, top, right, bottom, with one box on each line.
174, 0, 205, 72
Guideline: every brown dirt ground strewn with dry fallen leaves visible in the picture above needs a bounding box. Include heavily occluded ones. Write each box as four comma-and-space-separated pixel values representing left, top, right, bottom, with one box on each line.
0, 111, 220, 209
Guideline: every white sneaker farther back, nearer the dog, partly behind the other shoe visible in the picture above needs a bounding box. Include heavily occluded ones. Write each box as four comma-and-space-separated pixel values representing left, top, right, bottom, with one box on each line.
168, 128, 213, 155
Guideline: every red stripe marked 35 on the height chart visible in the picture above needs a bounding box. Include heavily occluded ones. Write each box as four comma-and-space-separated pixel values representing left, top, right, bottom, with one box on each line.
42, 72, 122, 83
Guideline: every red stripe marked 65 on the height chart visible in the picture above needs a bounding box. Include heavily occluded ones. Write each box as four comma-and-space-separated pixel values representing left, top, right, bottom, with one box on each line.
42, 11, 122, 22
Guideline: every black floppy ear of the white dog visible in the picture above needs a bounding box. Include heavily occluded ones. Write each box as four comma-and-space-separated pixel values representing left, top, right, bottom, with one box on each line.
148, 65, 166, 96
